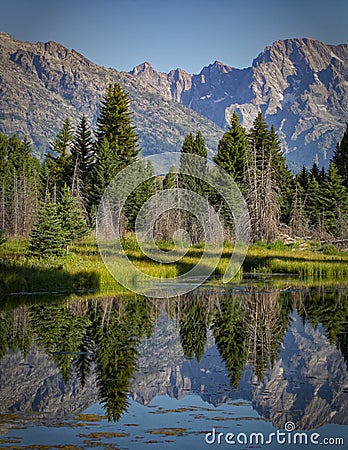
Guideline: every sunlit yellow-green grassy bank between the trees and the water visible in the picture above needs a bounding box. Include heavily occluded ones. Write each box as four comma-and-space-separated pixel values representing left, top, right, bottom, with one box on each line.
0, 235, 348, 294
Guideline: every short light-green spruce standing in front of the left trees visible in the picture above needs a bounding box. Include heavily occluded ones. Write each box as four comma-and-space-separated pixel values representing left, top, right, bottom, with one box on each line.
29, 199, 66, 257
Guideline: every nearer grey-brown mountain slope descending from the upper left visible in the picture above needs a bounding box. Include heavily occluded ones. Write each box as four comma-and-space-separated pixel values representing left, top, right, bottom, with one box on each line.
0, 33, 223, 157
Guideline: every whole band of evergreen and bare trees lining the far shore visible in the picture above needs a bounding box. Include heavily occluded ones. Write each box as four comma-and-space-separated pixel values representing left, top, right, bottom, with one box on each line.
0, 79, 348, 251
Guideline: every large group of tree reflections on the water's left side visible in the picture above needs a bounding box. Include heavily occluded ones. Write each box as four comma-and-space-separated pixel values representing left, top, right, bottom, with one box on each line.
0, 297, 152, 420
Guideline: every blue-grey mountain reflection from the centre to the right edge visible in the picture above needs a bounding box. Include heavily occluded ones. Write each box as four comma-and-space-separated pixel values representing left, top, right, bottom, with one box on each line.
128, 315, 348, 429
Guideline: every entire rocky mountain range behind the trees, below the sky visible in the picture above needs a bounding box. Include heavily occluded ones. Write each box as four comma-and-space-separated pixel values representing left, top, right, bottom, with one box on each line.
0, 33, 348, 167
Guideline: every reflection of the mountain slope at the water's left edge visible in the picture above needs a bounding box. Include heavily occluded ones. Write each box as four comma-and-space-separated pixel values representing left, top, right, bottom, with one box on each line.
0, 345, 98, 434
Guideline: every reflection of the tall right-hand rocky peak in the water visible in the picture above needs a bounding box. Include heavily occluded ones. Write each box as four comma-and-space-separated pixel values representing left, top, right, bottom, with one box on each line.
253, 316, 348, 429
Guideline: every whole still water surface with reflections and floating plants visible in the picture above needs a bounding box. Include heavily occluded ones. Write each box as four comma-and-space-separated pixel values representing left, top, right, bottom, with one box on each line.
0, 282, 348, 450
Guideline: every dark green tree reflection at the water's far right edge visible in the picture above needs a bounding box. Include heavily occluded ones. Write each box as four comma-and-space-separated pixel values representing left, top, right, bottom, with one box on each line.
295, 289, 348, 365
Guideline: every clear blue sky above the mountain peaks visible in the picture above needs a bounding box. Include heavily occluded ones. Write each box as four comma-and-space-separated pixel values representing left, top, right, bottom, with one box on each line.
0, 0, 348, 73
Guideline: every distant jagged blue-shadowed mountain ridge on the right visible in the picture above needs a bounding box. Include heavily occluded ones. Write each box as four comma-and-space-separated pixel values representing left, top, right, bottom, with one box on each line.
130, 38, 348, 165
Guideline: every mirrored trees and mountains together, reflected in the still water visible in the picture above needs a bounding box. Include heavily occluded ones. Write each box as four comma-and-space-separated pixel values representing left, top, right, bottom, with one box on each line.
0, 287, 348, 429
